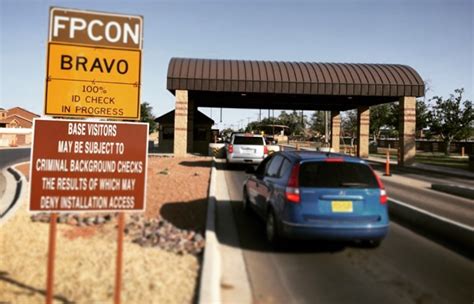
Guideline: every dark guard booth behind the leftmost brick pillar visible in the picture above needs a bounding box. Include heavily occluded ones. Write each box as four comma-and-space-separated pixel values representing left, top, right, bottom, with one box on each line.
155, 110, 214, 155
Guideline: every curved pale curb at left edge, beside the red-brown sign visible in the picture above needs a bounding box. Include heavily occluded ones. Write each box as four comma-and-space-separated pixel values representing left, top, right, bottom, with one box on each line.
0, 163, 27, 225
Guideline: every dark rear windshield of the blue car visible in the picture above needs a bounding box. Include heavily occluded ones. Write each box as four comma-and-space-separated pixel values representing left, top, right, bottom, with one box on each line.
299, 161, 378, 188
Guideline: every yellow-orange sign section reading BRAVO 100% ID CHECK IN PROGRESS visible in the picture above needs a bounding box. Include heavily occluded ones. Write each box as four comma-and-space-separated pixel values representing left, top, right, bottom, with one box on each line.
44, 43, 141, 119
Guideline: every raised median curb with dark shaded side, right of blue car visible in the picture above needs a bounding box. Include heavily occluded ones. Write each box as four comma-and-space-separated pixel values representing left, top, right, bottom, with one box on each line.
389, 198, 474, 259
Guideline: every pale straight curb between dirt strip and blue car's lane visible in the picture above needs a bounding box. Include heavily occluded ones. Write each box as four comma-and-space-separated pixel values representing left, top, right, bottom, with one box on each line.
198, 158, 221, 304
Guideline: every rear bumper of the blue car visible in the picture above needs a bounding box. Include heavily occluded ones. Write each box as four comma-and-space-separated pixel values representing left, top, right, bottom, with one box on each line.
281, 221, 389, 240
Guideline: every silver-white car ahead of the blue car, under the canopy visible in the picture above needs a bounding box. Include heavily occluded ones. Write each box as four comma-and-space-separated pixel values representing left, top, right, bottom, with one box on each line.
226, 134, 268, 165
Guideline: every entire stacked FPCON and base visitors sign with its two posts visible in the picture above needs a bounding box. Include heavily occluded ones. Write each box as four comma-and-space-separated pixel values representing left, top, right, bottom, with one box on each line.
30, 7, 144, 303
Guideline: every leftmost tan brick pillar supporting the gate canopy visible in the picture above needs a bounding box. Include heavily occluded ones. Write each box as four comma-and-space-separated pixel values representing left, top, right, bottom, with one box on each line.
174, 90, 189, 157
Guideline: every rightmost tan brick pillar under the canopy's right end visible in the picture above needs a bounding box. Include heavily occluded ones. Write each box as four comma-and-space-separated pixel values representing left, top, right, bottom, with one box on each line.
398, 96, 416, 166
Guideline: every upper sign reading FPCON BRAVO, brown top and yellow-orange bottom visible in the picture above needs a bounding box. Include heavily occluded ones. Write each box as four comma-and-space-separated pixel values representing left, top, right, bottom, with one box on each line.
44, 8, 143, 119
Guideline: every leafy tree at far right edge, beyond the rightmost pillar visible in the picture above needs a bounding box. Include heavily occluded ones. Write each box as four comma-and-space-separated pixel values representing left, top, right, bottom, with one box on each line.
428, 89, 474, 155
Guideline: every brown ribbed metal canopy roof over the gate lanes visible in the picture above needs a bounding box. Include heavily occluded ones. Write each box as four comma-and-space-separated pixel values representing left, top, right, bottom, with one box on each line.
167, 58, 424, 111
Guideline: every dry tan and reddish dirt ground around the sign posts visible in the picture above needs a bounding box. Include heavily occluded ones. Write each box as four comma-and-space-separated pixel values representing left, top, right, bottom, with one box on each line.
0, 157, 211, 303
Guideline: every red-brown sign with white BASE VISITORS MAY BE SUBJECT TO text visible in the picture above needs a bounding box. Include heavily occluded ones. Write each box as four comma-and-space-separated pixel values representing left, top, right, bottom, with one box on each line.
30, 119, 148, 212
